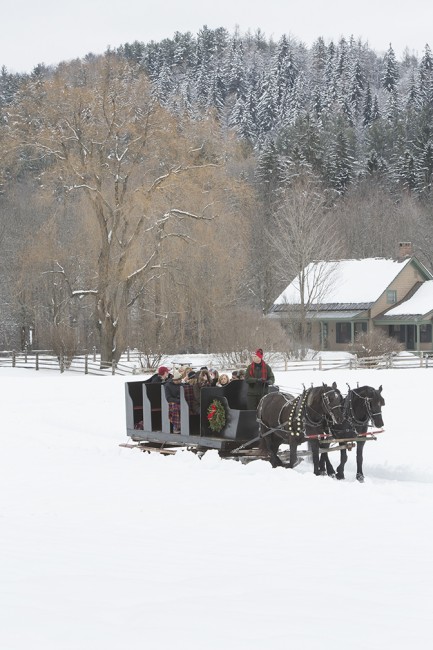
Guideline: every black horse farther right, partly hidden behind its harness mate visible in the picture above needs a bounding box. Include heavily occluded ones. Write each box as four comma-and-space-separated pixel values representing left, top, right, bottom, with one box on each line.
320, 386, 385, 483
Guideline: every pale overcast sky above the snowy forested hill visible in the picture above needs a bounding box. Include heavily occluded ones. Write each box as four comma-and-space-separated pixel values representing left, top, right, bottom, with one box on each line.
0, 0, 433, 72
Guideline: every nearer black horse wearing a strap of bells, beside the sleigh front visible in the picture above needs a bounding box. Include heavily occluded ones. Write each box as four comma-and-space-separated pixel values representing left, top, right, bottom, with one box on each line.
257, 382, 355, 475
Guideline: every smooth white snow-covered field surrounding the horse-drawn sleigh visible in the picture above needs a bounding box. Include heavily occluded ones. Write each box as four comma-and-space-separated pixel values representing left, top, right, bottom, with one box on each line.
0, 368, 433, 650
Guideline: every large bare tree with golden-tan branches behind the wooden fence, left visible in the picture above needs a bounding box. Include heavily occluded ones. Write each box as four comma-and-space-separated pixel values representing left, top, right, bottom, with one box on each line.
8, 55, 243, 364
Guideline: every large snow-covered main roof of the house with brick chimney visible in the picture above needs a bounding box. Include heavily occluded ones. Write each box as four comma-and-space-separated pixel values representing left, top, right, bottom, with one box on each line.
274, 258, 412, 305
